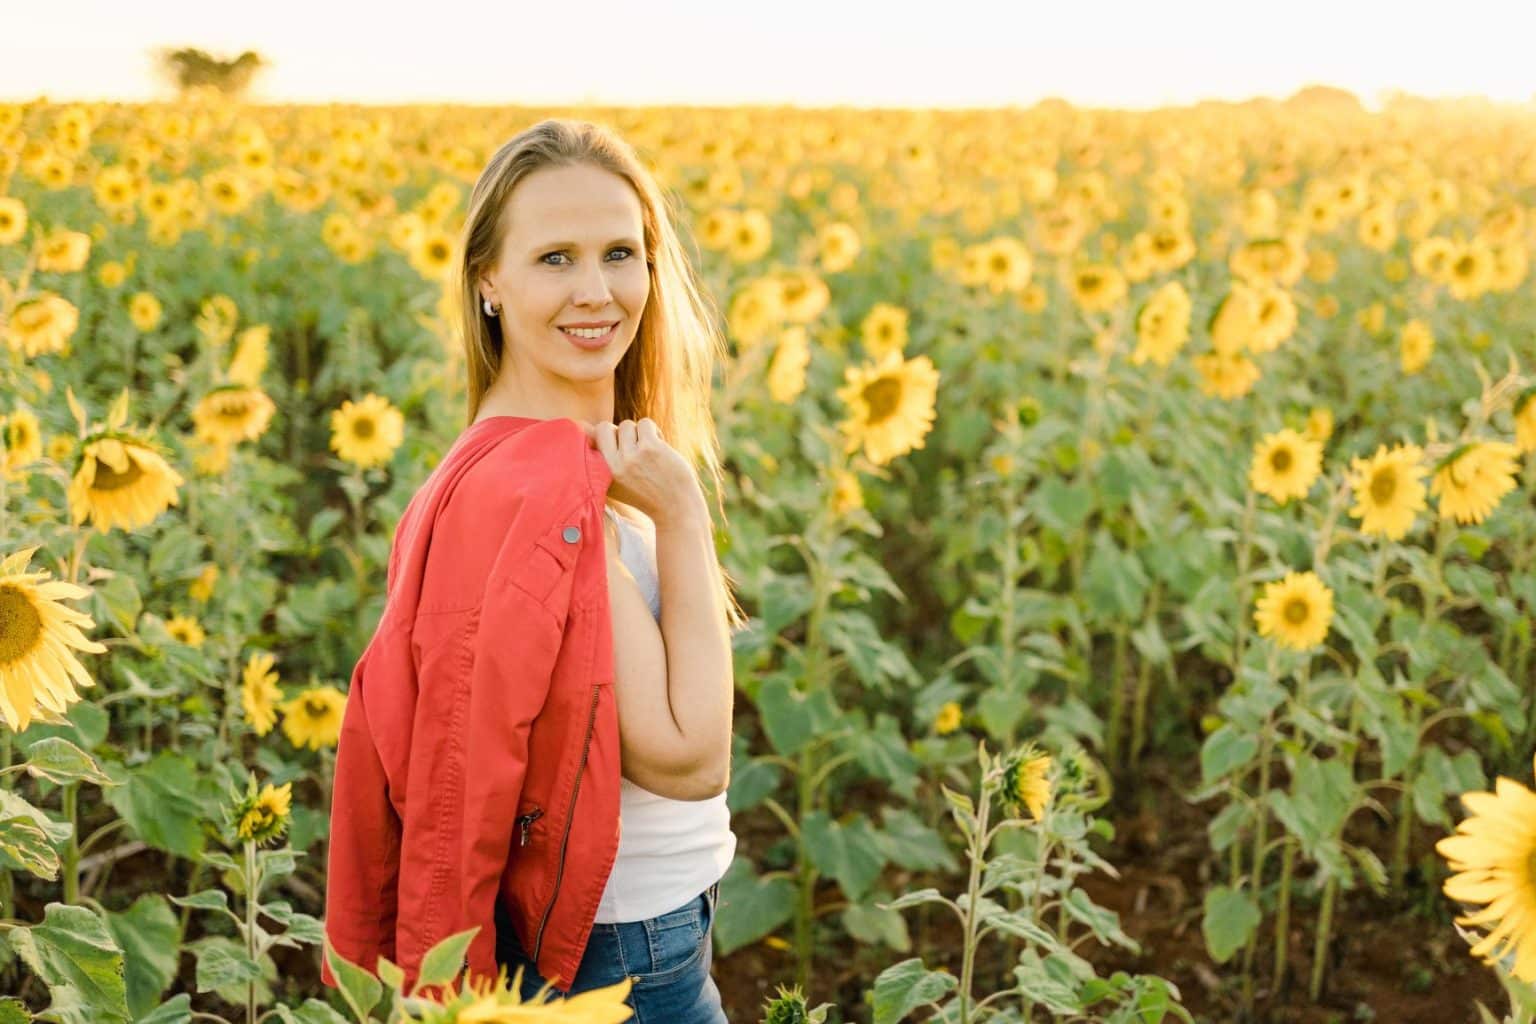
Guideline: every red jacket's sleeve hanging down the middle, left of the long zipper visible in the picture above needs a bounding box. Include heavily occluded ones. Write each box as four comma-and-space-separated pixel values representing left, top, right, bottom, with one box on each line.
459, 531, 568, 979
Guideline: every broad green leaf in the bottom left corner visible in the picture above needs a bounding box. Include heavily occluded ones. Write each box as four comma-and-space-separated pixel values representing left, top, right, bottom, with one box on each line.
9, 903, 129, 1024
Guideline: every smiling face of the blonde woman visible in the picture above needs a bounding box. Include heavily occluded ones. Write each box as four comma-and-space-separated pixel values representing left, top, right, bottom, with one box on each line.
479, 164, 651, 388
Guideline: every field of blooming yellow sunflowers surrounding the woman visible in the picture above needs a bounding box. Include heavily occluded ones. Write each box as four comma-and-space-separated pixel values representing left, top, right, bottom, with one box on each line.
0, 89, 1536, 1024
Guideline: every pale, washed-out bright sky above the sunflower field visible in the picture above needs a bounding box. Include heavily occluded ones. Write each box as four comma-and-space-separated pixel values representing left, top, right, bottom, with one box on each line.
9, 0, 1536, 107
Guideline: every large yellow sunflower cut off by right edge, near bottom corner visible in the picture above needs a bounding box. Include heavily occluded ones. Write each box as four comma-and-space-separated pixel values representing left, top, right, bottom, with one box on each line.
1435, 752, 1536, 983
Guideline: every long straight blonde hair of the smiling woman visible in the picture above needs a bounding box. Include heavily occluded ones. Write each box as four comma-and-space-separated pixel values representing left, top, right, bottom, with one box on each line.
458, 118, 746, 631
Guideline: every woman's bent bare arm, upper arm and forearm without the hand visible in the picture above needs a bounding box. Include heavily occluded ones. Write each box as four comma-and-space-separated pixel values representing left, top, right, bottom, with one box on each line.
608, 496, 734, 800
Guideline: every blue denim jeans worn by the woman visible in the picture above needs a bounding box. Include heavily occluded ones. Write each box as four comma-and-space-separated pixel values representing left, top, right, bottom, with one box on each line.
496, 883, 730, 1024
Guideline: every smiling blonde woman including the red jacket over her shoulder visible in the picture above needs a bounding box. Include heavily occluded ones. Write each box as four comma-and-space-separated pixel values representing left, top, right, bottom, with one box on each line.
321, 120, 745, 1024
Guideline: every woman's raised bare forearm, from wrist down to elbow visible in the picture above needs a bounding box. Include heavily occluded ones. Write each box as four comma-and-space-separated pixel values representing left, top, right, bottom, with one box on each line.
654, 491, 736, 788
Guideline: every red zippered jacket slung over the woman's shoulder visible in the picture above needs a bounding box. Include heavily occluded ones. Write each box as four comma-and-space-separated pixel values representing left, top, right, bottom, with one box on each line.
321, 416, 619, 992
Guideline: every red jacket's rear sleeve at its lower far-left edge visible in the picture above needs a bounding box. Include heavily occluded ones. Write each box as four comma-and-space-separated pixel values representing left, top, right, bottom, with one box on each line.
319, 659, 401, 987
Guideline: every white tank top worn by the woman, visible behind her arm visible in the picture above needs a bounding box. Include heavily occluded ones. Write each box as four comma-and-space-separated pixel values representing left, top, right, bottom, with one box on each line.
594, 505, 736, 924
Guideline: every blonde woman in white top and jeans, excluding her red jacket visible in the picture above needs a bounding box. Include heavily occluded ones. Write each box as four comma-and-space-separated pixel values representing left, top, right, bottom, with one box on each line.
462, 120, 749, 1024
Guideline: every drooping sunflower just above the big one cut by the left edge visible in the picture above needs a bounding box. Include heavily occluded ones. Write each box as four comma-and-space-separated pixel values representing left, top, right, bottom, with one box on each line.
69, 431, 186, 533
